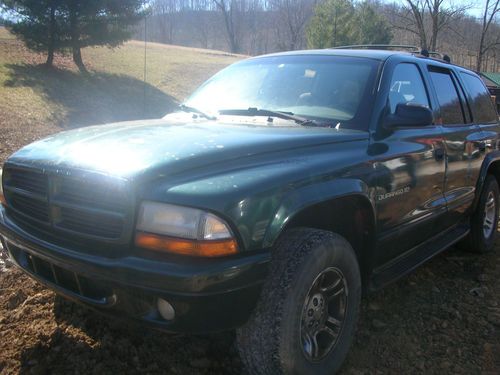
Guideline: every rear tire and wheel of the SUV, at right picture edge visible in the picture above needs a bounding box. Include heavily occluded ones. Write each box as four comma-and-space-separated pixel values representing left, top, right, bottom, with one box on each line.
460, 175, 500, 253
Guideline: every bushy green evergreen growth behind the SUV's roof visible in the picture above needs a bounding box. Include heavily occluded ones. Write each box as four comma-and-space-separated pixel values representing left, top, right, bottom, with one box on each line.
307, 0, 392, 48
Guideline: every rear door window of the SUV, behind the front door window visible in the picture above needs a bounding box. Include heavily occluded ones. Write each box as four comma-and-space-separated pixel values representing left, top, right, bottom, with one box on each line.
430, 71, 465, 124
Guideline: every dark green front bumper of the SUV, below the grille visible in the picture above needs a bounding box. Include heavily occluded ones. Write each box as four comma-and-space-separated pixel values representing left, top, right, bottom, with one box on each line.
0, 206, 270, 333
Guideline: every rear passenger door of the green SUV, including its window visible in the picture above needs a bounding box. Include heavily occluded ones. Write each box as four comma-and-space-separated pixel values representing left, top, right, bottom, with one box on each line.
428, 65, 484, 227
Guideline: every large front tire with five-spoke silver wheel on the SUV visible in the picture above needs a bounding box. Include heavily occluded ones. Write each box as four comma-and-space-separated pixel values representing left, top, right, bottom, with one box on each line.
237, 228, 361, 375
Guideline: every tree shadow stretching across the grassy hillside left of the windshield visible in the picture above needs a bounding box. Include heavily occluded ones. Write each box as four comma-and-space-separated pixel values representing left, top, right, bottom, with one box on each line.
4, 64, 176, 128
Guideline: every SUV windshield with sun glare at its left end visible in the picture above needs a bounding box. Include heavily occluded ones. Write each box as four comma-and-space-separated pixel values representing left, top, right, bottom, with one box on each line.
185, 55, 379, 130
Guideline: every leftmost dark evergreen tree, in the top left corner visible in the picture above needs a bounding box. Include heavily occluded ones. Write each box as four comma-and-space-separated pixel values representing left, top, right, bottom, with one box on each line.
2, 0, 63, 67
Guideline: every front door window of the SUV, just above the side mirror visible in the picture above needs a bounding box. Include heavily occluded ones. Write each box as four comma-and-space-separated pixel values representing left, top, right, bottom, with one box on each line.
389, 64, 429, 113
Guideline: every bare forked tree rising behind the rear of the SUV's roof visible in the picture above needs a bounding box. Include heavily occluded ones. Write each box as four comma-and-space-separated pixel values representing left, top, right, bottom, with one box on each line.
395, 0, 470, 51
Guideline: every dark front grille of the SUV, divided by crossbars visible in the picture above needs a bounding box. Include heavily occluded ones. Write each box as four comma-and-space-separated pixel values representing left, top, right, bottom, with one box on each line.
3, 166, 131, 241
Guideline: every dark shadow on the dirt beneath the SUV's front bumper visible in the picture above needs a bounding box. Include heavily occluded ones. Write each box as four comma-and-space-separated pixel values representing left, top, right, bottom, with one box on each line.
20, 296, 241, 374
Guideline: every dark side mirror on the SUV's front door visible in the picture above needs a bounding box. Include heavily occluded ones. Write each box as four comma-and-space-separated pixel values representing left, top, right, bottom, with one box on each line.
384, 103, 432, 128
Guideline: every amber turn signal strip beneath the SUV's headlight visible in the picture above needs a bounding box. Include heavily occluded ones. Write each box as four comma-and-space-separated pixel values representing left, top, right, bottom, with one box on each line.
135, 232, 238, 257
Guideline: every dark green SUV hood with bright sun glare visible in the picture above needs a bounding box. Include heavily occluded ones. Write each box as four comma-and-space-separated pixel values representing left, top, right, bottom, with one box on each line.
8, 119, 367, 179
